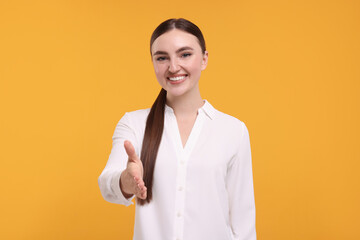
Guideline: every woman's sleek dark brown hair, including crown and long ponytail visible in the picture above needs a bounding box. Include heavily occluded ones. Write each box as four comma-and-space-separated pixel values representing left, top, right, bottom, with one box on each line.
136, 18, 206, 205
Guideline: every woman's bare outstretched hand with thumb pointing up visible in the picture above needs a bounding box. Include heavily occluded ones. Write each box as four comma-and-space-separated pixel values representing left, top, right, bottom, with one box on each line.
120, 141, 147, 199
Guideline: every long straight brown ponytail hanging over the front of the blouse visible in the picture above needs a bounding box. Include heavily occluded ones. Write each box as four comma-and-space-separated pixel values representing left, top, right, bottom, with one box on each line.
136, 88, 166, 205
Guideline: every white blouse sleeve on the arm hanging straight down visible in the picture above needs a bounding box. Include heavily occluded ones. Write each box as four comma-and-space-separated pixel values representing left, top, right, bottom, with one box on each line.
226, 122, 256, 240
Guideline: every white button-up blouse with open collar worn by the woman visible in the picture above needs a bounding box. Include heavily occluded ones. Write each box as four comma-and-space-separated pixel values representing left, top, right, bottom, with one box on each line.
98, 100, 256, 240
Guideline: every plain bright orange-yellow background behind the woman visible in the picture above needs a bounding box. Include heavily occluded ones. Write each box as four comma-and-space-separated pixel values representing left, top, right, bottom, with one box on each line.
0, 0, 360, 240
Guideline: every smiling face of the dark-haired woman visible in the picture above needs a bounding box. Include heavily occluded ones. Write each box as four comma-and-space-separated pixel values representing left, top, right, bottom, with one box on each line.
151, 29, 208, 97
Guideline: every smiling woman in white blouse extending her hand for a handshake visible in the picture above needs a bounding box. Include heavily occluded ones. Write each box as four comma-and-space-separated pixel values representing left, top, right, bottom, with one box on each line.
98, 18, 256, 240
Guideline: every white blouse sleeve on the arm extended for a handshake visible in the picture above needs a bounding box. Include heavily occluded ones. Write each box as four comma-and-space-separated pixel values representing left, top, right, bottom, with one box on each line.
98, 113, 139, 206
